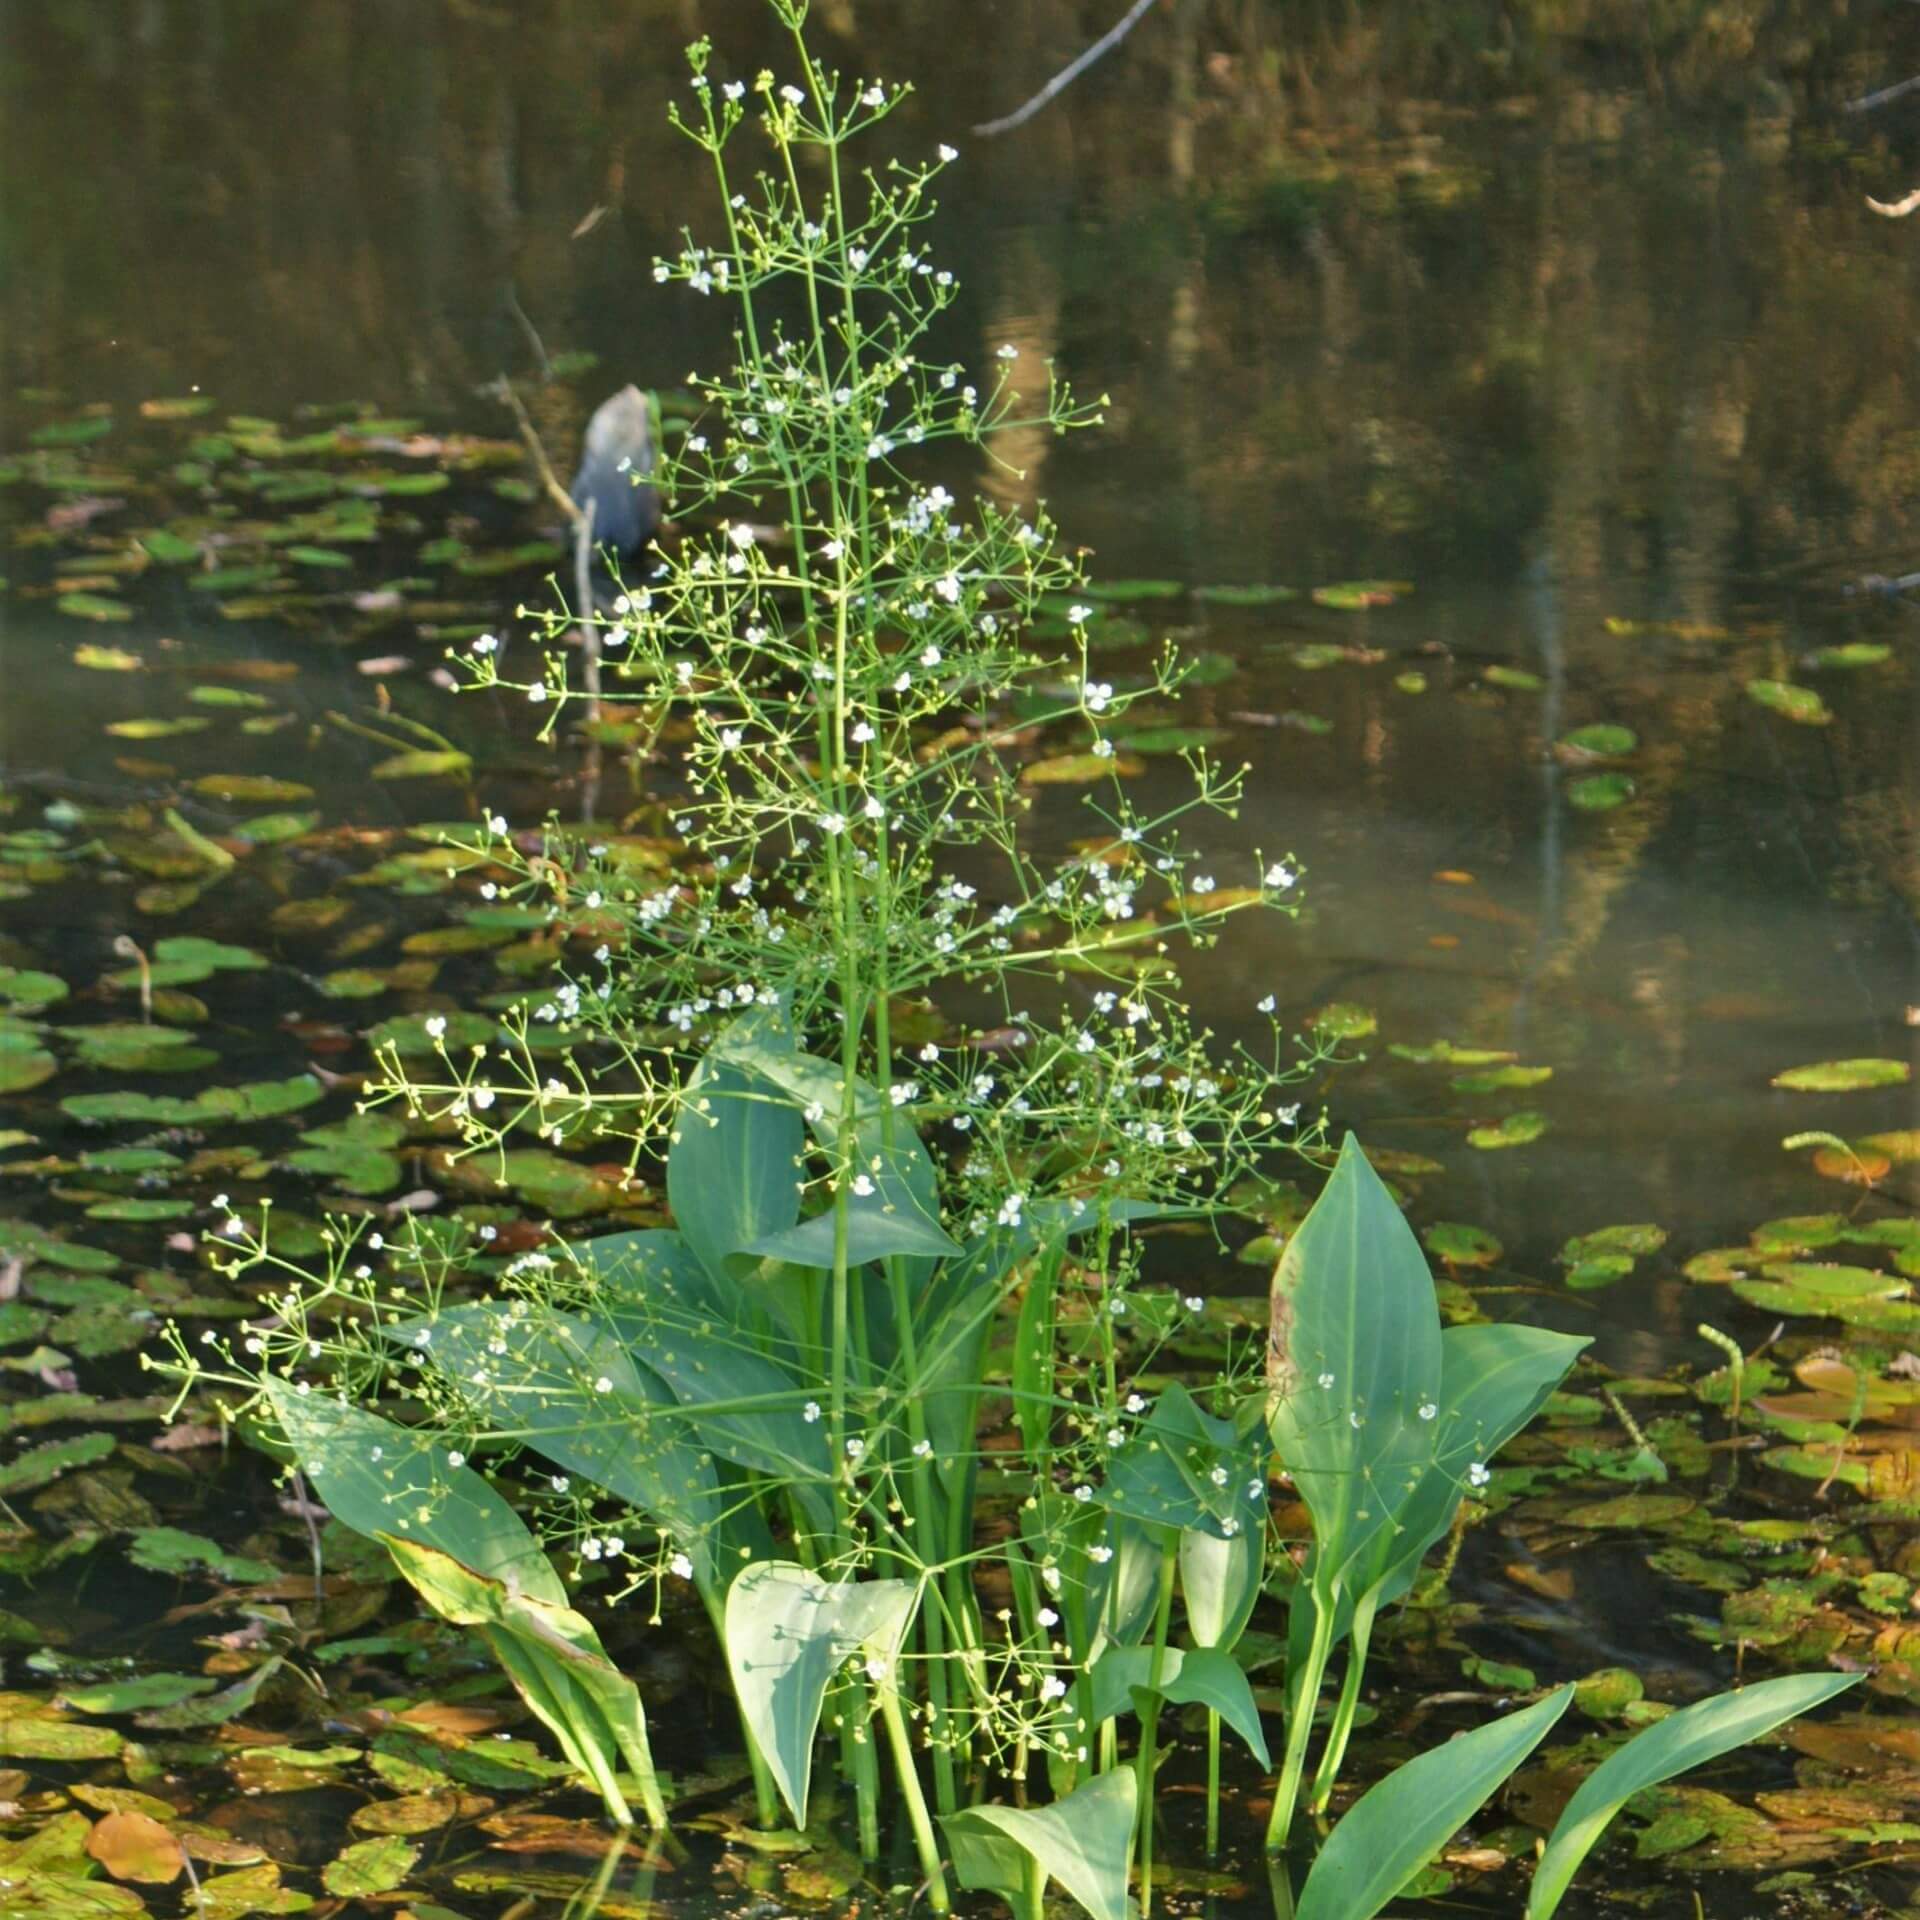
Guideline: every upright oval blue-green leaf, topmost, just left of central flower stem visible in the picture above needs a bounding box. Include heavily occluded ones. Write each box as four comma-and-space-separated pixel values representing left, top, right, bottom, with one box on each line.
666, 1027, 806, 1281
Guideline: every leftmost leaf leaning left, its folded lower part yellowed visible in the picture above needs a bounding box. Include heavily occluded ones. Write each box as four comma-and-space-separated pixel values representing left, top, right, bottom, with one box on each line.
267, 1380, 666, 1826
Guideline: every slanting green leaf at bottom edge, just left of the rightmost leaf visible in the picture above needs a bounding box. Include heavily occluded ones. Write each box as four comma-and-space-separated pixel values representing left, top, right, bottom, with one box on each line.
1294, 1686, 1572, 1920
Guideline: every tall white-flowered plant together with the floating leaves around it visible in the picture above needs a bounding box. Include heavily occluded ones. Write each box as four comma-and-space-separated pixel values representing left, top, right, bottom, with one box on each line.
0, 0, 1920, 1920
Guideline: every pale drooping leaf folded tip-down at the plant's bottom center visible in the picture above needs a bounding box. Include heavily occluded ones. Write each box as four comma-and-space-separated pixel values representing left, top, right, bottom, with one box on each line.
726, 1561, 918, 1826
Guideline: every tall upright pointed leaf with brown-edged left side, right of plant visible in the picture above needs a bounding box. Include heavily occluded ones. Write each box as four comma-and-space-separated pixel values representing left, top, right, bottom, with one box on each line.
1267, 1135, 1442, 1599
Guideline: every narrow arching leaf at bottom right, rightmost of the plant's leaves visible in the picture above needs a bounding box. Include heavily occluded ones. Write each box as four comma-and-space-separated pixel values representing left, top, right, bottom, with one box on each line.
1526, 1674, 1862, 1920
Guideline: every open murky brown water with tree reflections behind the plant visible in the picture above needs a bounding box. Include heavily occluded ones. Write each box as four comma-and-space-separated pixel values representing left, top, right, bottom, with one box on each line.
0, 0, 1920, 1338
